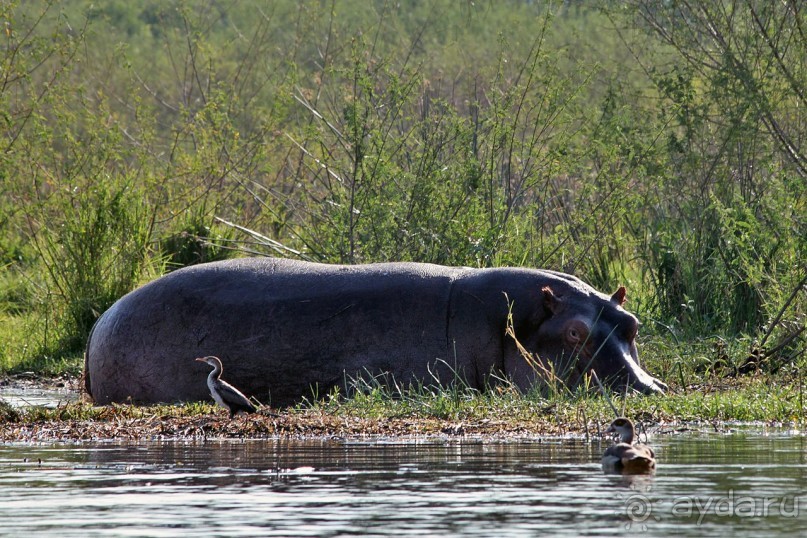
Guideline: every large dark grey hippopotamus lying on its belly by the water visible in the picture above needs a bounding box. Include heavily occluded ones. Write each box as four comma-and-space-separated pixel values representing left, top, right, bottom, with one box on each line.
85, 258, 665, 406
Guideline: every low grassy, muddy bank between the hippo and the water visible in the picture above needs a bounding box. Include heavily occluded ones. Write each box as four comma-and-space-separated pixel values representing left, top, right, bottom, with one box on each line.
0, 370, 804, 442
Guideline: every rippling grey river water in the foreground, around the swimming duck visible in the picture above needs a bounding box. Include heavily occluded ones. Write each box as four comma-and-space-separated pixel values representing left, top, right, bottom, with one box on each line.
0, 432, 807, 536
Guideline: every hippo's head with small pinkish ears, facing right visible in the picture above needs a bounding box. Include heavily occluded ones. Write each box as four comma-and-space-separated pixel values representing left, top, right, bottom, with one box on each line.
508, 286, 667, 394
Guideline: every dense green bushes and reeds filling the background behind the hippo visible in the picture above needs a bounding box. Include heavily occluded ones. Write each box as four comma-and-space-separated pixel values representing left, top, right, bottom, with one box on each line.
0, 0, 807, 401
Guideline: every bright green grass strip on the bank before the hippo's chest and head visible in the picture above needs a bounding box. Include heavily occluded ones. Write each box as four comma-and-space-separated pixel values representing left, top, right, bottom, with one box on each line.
300, 354, 805, 424
